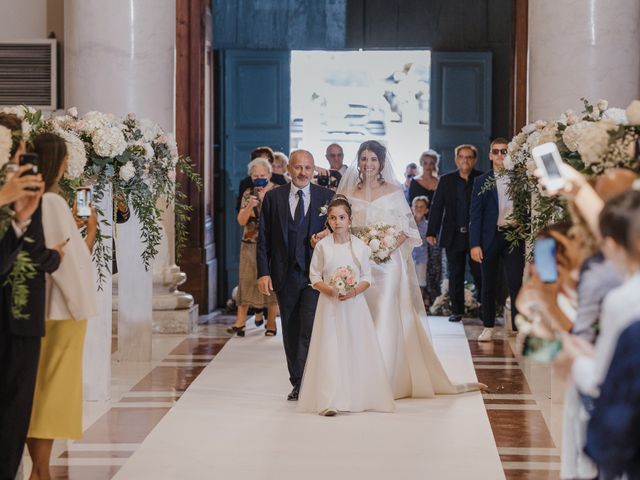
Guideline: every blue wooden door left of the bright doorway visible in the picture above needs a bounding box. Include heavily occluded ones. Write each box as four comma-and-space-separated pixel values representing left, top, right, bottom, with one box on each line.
220, 50, 291, 295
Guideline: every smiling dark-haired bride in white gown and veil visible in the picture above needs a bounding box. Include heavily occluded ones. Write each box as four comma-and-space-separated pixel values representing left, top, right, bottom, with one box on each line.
337, 140, 484, 399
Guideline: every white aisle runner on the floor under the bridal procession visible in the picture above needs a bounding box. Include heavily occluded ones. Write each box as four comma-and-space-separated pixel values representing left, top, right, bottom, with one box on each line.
115, 317, 504, 480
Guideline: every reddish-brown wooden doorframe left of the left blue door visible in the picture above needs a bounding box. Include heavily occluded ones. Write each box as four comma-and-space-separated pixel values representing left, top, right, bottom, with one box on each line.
176, 0, 216, 314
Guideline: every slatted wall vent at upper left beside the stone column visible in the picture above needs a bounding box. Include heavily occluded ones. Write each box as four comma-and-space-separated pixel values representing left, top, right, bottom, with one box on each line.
0, 39, 57, 110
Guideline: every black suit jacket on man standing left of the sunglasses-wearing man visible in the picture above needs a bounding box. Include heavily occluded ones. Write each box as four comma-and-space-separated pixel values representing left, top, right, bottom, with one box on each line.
427, 169, 482, 249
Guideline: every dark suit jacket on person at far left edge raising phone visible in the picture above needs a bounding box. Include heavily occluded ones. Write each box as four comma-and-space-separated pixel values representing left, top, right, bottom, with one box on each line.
2, 203, 60, 337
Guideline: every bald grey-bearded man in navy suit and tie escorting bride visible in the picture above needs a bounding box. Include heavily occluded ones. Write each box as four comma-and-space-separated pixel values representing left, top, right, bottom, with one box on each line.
257, 150, 333, 400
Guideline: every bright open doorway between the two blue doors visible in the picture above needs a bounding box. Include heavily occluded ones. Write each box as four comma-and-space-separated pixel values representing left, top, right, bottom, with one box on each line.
290, 50, 431, 181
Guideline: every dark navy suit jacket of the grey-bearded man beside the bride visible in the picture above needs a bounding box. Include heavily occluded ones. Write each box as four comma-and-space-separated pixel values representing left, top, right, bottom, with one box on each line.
257, 184, 333, 292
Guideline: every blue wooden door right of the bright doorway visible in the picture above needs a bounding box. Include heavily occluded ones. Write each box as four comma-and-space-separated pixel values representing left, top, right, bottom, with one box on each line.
429, 52, 491, 173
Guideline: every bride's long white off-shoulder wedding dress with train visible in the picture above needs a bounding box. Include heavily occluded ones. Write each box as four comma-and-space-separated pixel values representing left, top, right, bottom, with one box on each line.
347, 188, 480, 399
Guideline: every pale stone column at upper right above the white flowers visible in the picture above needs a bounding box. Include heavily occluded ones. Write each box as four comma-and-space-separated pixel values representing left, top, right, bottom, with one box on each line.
528, 0, 640, 122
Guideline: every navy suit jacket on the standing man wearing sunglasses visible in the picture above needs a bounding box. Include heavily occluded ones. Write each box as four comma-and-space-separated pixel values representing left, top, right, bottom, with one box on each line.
469, 170, 500, 251
